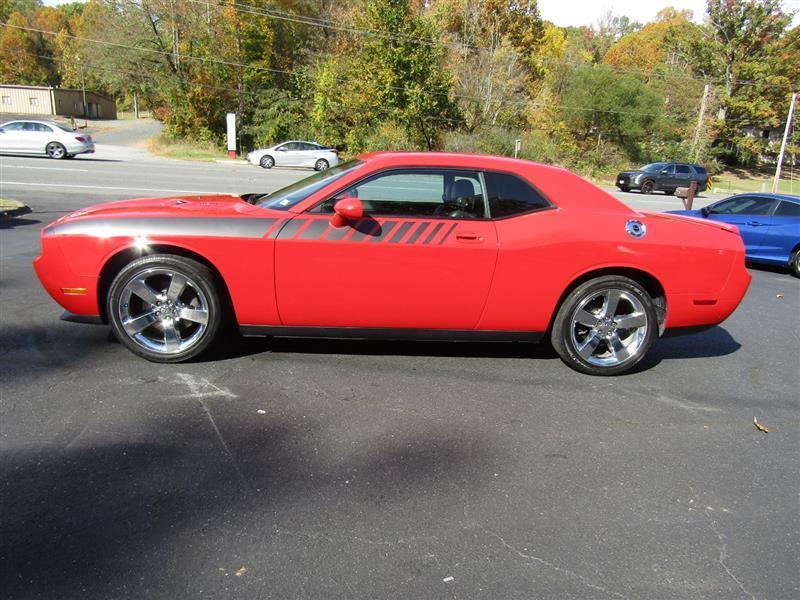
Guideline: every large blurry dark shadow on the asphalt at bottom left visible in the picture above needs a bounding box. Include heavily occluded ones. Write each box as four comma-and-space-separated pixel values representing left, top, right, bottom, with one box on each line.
0, 412, 498, 599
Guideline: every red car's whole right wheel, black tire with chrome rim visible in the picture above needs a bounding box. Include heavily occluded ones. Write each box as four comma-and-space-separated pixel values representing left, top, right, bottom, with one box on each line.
550, 275, 658, 375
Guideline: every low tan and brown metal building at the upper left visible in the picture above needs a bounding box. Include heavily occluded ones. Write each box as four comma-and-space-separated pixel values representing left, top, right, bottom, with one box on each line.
0, 85, 117, 119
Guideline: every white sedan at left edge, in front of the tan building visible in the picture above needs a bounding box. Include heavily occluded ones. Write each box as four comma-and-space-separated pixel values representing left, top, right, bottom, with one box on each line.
0, 119, 94, 158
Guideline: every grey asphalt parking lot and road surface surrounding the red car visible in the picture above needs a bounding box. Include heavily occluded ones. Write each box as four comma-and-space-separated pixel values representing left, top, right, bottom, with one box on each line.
0, 152, 800, 599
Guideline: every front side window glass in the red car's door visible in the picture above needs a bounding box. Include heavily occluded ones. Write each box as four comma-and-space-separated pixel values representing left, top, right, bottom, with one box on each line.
312, 169, 485, 219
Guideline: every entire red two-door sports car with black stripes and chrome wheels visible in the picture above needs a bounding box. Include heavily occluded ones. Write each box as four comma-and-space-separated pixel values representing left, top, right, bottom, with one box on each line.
34, 153, 750, 375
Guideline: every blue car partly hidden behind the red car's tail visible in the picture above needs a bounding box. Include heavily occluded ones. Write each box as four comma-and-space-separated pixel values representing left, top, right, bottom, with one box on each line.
669, 193, 800, 277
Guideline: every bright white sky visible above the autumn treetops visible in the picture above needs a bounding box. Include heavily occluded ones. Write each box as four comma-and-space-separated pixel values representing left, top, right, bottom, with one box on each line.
44, 0, 800, 27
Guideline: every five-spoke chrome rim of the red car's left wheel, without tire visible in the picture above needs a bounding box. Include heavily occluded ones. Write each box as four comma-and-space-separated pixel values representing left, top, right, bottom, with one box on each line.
118, 268, 210, 354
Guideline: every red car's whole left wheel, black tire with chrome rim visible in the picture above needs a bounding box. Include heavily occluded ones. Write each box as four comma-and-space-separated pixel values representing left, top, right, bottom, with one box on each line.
107, 254, 224, 363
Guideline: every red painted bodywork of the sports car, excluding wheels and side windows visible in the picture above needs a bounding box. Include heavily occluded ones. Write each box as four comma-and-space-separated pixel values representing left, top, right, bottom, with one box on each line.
34, 153, 750, 332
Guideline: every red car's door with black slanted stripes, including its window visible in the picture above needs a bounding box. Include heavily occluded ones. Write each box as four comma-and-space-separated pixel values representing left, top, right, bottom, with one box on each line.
275, 168, 498, 330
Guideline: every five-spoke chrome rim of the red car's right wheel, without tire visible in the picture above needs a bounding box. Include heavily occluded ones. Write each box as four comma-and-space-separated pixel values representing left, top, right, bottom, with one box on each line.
570, 288, 649, 367
